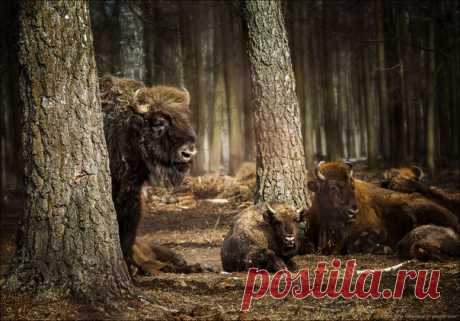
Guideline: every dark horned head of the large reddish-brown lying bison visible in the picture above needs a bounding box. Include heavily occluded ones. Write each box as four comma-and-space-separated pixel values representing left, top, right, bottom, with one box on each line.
308, 162, 358, 249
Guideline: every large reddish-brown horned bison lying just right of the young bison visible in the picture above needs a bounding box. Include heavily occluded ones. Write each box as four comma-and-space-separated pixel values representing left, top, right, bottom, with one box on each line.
308, 163, 459, 253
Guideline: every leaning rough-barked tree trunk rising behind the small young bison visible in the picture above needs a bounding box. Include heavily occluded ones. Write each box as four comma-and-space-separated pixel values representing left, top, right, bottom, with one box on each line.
245, 0, 310, 206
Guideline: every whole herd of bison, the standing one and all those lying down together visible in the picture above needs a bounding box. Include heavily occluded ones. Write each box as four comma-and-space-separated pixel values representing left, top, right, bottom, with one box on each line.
100, 76, 460, 273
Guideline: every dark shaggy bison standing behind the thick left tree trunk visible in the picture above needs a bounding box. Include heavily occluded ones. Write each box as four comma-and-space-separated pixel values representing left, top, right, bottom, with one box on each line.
100, 76, 196, 265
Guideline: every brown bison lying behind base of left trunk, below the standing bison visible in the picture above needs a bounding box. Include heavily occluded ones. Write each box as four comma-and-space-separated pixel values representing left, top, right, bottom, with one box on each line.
133, 235, 213, 275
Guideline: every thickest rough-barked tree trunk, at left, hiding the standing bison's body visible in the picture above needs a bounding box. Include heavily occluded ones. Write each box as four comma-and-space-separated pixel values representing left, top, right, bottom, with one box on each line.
7, 0, 131, 299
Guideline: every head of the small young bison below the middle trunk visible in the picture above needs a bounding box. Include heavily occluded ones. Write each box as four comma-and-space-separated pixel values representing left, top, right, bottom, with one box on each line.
263, 203, 306, 257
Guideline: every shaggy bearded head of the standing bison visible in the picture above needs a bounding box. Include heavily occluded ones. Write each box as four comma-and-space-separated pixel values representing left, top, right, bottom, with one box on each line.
133, 86, 197, 186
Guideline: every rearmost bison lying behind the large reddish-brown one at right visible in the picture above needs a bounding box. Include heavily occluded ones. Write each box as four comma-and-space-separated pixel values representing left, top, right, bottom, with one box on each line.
382, 166, 460, 218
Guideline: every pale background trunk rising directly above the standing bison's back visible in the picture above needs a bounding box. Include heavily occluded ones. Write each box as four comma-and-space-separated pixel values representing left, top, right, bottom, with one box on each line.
119, 0, 145, 81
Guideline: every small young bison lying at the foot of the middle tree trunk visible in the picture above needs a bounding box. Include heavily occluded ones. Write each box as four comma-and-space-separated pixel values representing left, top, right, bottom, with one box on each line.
221, 204, 305, 272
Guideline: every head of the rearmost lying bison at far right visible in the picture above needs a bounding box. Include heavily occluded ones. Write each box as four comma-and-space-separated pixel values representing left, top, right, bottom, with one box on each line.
381, 166, 424, 193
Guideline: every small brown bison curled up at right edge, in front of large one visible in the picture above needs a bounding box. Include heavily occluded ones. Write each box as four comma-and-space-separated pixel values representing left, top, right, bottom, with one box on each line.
398, 225, 460, 261
